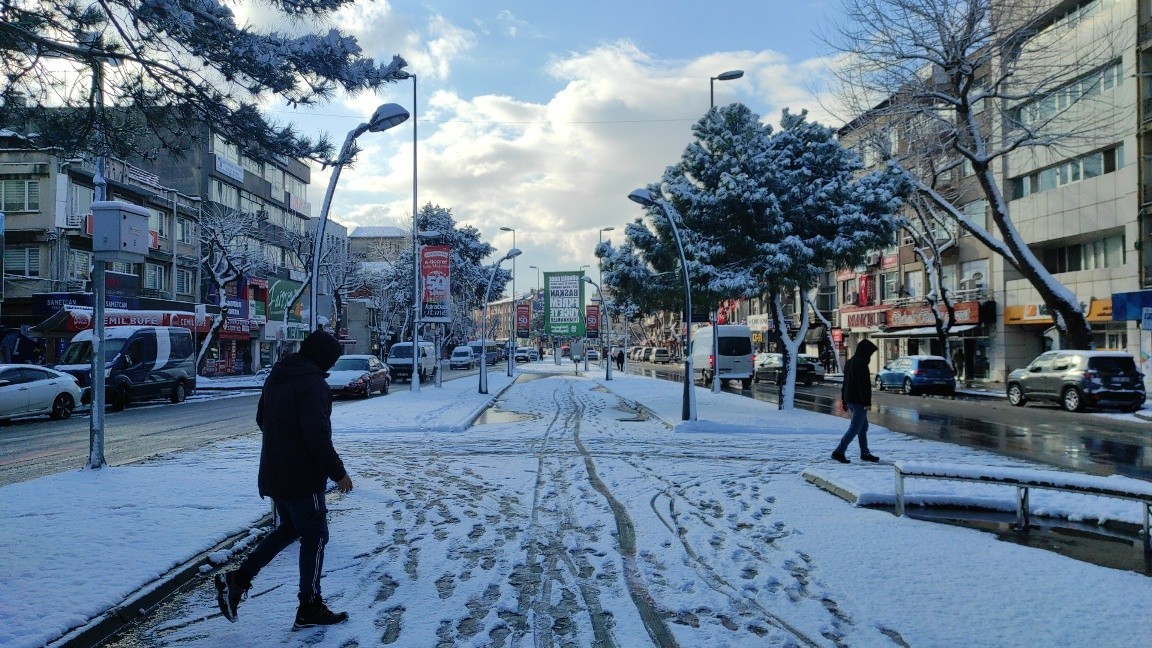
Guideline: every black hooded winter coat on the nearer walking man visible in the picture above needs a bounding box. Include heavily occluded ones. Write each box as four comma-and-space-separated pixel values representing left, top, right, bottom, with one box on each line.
256, 353, 347, 499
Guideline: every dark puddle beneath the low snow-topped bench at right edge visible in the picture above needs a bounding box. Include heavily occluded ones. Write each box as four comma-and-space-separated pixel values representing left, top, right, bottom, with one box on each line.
908, 508, 1152, 577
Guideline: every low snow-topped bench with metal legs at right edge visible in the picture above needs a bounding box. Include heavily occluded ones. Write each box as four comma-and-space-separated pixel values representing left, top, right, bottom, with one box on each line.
893, 461, 1152, 553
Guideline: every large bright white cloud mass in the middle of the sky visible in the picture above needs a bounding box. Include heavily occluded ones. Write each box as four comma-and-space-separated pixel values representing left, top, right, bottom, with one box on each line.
329, 42, 831, 273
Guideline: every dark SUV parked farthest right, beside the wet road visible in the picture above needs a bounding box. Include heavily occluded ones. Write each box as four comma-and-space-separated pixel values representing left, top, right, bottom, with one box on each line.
1008, 349, 1146, 412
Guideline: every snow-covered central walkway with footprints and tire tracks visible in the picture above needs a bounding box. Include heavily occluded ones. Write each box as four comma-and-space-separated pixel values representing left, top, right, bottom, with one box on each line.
0, 361, 1152, 648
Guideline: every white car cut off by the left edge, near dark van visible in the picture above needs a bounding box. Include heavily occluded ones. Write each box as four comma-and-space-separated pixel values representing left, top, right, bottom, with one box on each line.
0, 364, 81, 421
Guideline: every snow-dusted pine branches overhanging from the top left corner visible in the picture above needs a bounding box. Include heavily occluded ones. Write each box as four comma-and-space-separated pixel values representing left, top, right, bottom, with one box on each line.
0, 0, 407, 161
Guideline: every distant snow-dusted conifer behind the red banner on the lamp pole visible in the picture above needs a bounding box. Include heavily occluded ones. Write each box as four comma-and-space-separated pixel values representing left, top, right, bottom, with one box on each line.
378, 203, 511, 344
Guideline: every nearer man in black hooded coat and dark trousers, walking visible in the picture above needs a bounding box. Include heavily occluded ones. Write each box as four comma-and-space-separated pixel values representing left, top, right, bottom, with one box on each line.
215, 331, 353, 628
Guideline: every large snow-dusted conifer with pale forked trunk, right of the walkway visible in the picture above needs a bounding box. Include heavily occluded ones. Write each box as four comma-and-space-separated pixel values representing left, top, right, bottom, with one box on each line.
617, 104, 905, 409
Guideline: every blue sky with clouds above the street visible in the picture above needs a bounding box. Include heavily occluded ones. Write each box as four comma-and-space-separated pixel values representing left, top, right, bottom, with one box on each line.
250, 0, 838, 291
